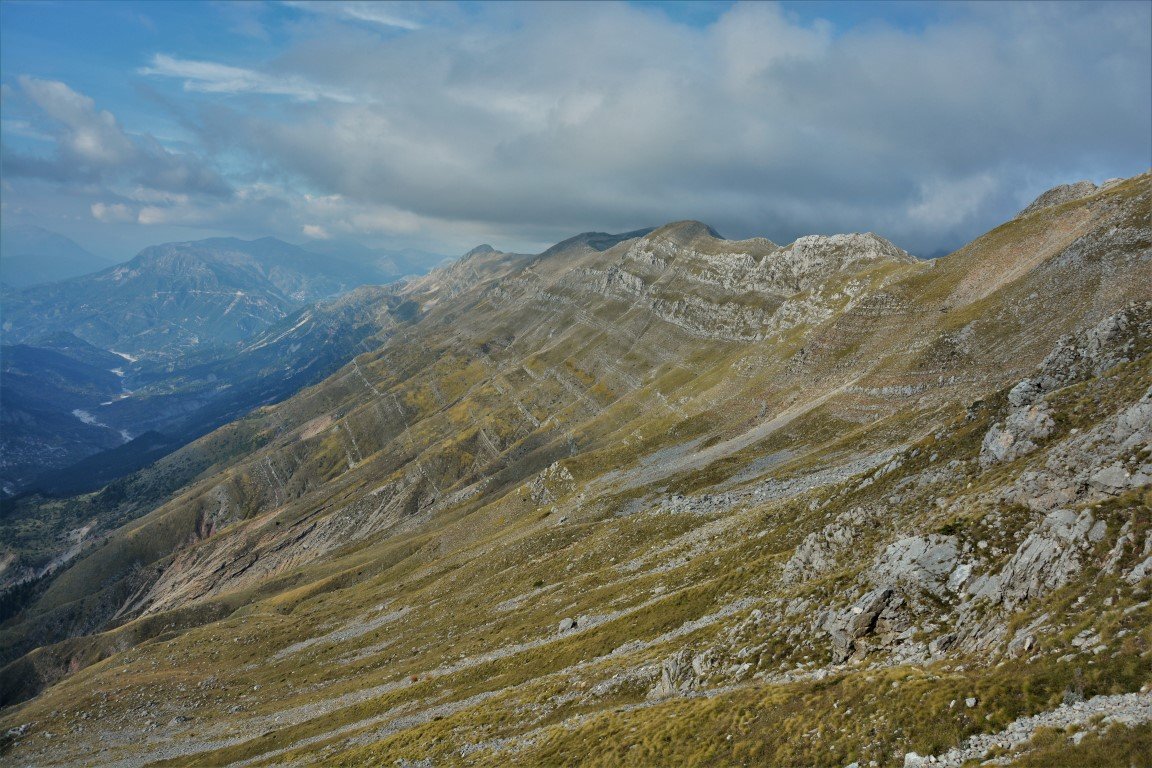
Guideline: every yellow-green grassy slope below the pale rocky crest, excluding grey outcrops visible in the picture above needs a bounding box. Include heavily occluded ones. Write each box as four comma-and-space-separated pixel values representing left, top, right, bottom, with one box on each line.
3, 171, 1152, 765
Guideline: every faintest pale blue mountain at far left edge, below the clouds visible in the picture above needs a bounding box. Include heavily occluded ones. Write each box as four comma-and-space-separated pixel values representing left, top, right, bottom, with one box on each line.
0, 225, 114, 288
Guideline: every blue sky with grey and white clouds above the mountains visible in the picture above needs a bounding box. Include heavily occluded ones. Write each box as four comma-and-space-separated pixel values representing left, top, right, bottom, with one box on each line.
0, 0, 1152, 259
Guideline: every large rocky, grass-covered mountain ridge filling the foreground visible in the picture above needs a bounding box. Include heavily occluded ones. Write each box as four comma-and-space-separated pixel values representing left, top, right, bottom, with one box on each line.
0, 174, 1152, 766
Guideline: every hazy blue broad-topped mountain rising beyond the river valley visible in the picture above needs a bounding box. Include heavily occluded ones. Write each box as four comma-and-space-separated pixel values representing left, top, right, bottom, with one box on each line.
3, 237, 393, 359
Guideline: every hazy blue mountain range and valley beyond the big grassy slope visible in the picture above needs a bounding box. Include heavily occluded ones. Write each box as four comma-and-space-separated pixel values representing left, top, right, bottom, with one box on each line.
0, 237, 440, 495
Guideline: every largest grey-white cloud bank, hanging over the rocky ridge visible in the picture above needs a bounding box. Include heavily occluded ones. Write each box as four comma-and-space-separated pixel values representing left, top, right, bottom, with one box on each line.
170, 3, 1152, 251
